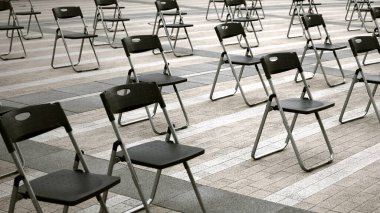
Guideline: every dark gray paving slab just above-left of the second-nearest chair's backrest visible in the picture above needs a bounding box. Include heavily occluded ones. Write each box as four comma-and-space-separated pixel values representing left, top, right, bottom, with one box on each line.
56, 82, 112, 95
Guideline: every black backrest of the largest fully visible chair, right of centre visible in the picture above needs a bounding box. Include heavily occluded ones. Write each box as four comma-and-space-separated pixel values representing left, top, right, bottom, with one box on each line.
260, 52, 303, 79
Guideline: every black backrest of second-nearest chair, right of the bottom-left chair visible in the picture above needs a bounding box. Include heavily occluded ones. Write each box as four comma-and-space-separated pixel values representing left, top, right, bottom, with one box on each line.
100, 83, 166, 122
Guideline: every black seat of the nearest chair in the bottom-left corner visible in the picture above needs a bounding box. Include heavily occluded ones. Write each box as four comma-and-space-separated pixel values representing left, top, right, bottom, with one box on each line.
19, 170, 120, 206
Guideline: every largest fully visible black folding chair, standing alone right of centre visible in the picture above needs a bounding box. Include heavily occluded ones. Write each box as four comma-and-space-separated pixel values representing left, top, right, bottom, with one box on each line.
251, 52, 335, 172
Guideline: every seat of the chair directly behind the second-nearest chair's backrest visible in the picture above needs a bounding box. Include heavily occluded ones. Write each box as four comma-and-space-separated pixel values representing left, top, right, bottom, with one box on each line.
138, 73, 187, 87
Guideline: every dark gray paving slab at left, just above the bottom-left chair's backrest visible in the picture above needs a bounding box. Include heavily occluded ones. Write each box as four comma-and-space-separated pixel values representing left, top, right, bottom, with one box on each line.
6, 90, 76, 105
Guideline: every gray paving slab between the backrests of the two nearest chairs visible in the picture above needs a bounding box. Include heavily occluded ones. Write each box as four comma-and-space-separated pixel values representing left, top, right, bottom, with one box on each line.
61, 95, 103, 113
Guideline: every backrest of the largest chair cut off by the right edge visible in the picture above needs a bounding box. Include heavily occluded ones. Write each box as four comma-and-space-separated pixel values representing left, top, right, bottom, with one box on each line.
348, 36, 380, 57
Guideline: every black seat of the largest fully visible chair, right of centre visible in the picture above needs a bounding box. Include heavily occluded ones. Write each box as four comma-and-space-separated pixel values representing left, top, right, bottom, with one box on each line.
272, 98, 335, 114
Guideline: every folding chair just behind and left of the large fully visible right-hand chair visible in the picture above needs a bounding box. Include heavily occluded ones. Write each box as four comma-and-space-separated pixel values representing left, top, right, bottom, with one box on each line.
210, 22, 269, 106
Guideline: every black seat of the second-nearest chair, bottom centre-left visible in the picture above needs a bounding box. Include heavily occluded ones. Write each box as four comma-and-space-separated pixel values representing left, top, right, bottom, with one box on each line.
116, 140, 205, 169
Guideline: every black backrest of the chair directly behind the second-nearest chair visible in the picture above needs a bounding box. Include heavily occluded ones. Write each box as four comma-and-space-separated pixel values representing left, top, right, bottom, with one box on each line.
121, 35, 164, 57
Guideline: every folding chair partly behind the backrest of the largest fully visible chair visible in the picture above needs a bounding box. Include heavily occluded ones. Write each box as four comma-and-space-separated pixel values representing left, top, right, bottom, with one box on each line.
294, 14, 347, 87
